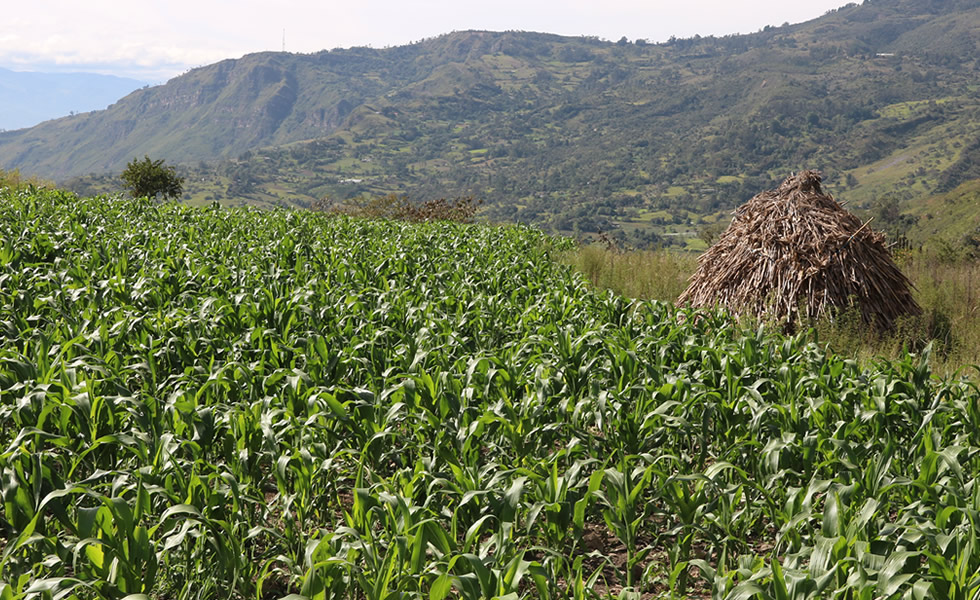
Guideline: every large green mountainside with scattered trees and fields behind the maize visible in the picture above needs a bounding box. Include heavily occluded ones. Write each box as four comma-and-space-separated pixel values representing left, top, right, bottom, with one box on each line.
0, 0, 980, 245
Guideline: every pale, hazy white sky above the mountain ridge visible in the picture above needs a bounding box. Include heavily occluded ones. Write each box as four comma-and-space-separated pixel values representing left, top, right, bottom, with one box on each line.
0, 0, 849, 83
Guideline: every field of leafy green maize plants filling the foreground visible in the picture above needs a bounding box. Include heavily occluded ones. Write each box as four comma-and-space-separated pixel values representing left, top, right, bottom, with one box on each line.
0, 188, 980, 600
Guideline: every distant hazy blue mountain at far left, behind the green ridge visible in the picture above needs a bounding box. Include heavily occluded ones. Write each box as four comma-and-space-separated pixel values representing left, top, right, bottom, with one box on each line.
0, 69, 146, 130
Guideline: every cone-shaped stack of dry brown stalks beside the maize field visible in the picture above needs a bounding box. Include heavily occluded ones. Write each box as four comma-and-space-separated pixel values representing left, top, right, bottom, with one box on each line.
678, 171, 922, 329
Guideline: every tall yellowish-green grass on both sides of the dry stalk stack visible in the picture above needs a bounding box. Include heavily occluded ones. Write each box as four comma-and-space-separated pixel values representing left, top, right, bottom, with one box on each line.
565, 245, 980, 373
